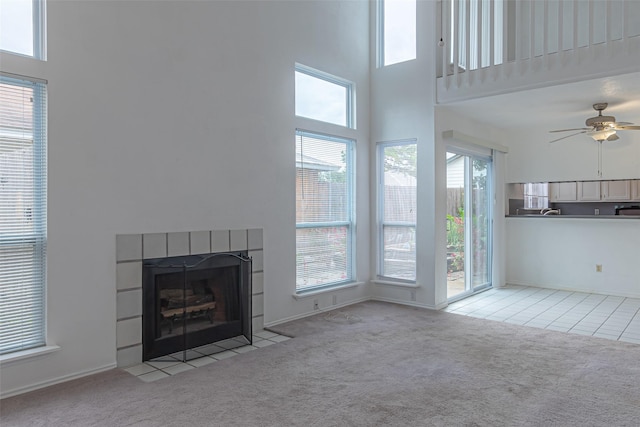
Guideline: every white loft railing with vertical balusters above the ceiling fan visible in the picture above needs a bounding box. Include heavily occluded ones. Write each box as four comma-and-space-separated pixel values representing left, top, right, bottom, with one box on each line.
437, 0, 640, 90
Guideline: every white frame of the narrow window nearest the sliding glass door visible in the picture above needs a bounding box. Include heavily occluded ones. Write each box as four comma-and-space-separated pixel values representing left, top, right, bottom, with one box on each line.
376, 138, 418, 284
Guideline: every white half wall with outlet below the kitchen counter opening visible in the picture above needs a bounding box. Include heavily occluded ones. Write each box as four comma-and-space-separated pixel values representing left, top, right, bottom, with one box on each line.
506, 218, 640, 298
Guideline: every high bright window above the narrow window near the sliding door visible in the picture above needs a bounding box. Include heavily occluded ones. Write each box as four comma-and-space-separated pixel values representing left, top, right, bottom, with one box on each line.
378, 0, 416, 66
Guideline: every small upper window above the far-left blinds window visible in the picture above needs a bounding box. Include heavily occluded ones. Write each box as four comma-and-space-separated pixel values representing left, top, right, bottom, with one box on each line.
0, 0, 45, 59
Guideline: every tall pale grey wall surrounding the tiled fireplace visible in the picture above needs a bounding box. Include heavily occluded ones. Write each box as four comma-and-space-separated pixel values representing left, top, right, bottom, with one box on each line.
0, 0, 370, 394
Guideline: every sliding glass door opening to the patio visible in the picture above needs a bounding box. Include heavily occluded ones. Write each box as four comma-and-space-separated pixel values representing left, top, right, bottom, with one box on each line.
446, 149, 493, 299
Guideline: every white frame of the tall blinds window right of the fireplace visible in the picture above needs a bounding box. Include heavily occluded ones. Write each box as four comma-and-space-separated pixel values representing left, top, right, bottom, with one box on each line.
295, 128, 356, 295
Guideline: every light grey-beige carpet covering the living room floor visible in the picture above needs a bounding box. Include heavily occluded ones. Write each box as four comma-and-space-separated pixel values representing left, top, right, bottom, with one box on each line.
0, 302, 640, 427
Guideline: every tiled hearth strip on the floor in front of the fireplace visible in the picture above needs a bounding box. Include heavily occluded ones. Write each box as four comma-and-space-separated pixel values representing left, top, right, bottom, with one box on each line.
124, 331, 291, 382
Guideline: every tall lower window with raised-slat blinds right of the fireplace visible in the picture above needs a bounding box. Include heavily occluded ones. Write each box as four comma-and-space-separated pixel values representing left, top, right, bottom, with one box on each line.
296, 130, 354, 291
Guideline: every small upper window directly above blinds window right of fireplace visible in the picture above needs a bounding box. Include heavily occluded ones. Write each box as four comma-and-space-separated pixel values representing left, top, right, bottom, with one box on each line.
295, 64, 355, 128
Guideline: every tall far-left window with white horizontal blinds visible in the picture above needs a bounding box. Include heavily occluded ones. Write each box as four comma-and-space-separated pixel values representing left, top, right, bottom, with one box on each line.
0, 75, 47, 354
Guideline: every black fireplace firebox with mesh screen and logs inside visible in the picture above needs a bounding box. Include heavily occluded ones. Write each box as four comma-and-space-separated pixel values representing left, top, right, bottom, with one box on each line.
142, 251, 251, 360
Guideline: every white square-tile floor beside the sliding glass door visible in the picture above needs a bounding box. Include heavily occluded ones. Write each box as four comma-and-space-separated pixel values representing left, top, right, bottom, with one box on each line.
443, 285, 640, 344
